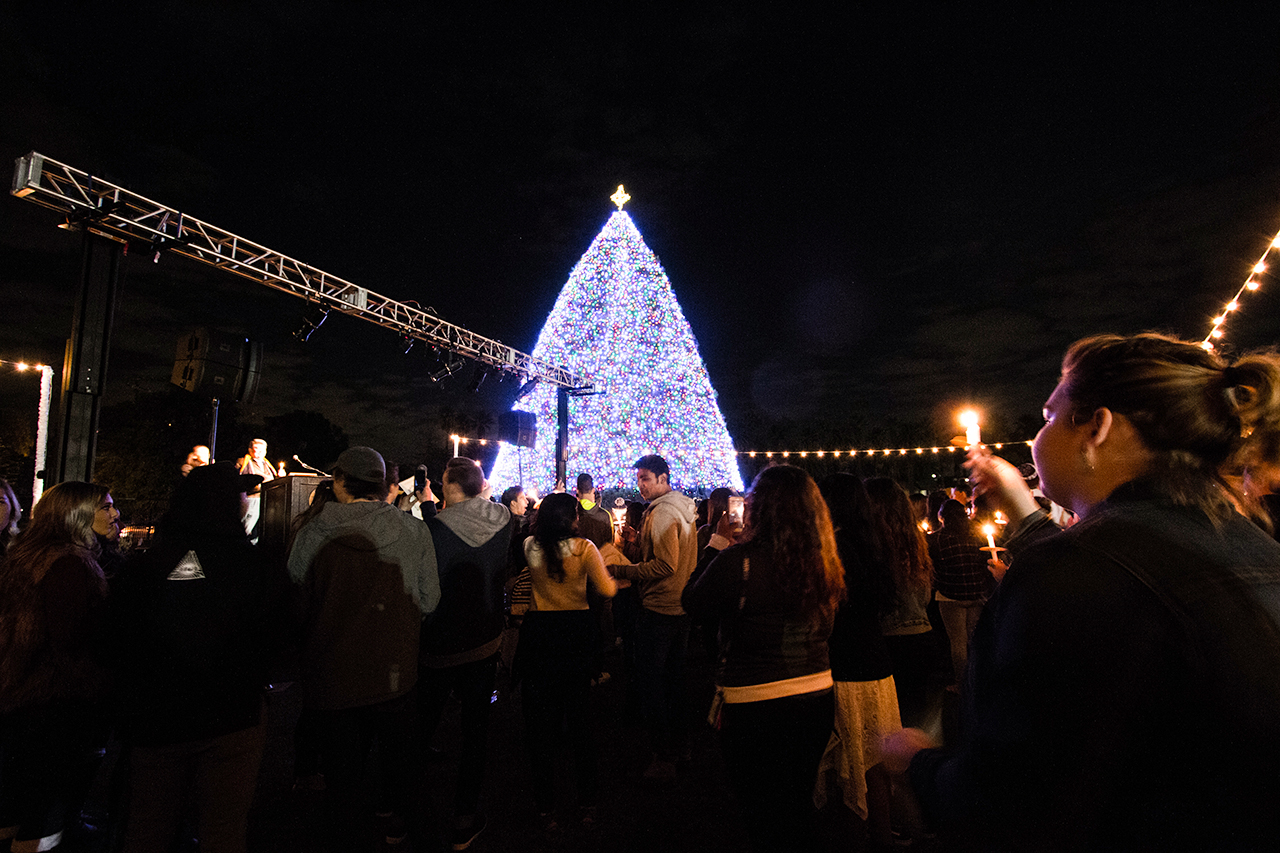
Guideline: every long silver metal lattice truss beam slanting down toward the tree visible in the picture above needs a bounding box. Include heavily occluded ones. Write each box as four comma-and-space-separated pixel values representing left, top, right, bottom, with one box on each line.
12, 151, 593, 393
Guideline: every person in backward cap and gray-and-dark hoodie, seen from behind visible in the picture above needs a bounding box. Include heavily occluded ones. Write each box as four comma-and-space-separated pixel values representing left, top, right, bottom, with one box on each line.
289, 447, 440, 850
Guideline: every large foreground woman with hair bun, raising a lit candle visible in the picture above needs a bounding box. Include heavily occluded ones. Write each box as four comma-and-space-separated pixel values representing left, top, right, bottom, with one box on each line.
886, 334, 1280, 850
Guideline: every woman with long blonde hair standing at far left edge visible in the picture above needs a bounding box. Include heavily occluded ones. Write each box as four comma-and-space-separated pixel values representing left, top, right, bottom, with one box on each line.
0, 482, 114, 850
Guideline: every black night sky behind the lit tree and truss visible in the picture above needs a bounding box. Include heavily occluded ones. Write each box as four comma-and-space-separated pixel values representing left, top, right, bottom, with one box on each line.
0, 0, 1280, 466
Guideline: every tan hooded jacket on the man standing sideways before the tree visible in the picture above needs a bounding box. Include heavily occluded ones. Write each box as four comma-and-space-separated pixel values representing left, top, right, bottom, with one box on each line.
612, 491, 698, 616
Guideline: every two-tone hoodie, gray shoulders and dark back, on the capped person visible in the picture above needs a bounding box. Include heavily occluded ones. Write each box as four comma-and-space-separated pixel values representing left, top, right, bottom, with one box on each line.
289, 501, 440, 710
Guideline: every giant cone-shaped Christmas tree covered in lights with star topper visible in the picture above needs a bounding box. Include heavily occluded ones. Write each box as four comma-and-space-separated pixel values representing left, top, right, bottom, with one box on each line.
489, 187, 742, 493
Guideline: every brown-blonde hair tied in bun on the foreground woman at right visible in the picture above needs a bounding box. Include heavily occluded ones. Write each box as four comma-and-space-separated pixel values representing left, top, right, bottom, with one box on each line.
1061, 332, 1280, 519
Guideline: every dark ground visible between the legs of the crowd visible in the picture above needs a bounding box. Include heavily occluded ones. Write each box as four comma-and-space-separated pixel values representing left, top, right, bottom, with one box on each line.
74, 622, 952, 853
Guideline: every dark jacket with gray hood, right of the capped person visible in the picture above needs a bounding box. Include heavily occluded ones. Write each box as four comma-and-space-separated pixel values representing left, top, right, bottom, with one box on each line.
421, 497, 516, 669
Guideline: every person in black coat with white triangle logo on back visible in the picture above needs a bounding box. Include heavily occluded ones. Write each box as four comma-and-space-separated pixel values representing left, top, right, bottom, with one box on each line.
111, 464, 285, 853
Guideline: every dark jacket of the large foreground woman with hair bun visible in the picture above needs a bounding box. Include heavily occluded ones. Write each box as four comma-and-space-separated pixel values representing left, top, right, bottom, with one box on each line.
910, 483, 1280, 850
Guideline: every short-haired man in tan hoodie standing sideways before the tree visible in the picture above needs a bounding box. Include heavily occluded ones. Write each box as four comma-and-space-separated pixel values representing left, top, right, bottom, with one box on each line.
612, 455, 698, 781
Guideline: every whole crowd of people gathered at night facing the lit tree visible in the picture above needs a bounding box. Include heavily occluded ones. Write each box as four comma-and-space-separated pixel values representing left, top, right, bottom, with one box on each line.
0, 334, 1280, 853
